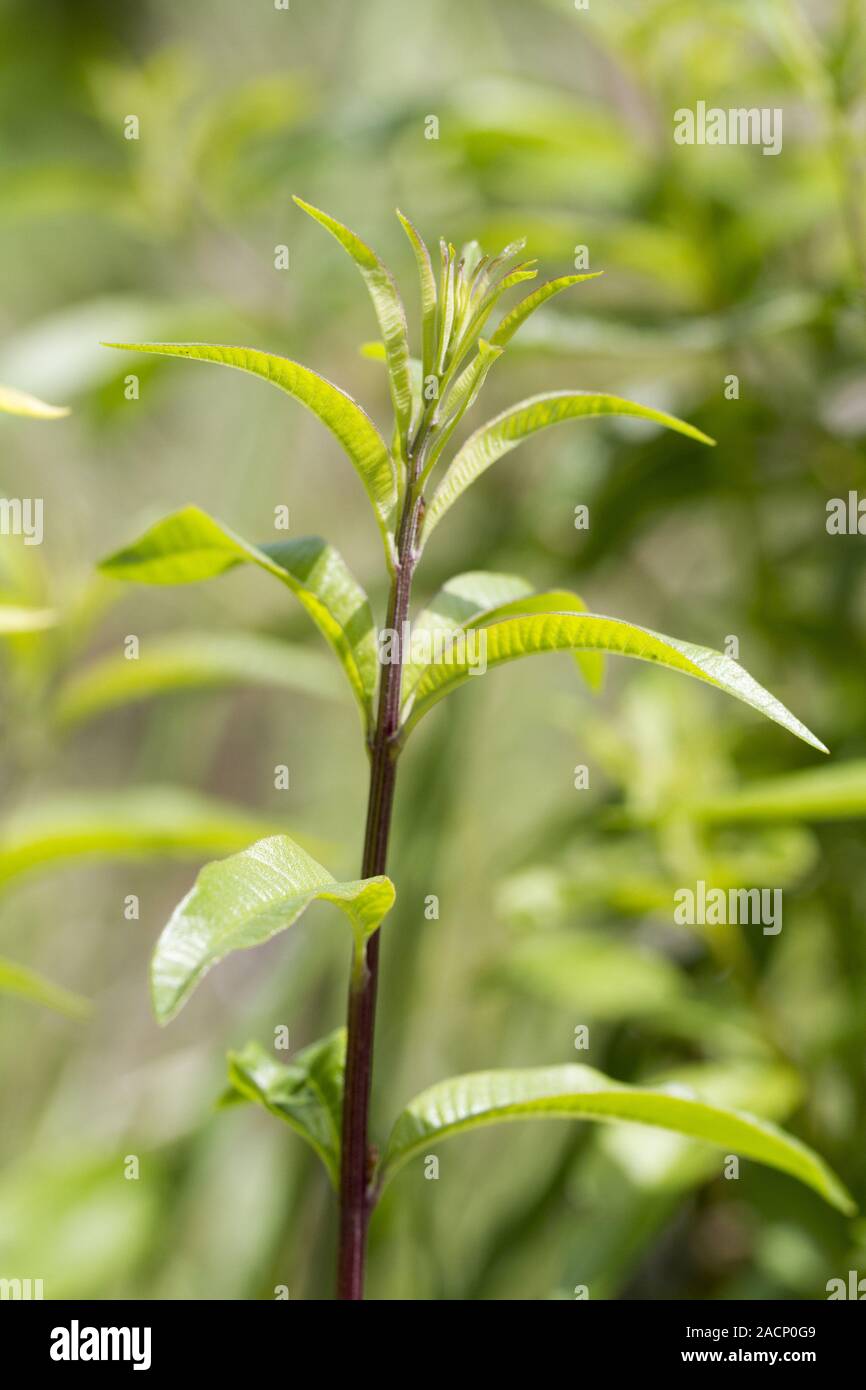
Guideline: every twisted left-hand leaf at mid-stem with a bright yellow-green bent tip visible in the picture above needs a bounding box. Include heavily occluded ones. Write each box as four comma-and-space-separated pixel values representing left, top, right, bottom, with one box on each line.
100, 507, 378, 726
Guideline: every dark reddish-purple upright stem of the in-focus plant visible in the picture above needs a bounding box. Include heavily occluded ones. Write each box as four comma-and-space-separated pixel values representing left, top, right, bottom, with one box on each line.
336, 464, 421, 1300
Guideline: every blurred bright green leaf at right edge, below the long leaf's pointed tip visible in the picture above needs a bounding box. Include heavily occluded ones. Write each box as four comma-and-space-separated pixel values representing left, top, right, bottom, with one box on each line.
681, 758, 866, 826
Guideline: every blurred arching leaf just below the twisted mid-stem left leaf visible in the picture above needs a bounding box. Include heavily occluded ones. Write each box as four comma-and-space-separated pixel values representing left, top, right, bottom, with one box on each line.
54, 632, 343, 724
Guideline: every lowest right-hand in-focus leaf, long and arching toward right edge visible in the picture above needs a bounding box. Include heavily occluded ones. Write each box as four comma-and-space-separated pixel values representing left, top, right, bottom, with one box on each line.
381, 1066, 856, 1215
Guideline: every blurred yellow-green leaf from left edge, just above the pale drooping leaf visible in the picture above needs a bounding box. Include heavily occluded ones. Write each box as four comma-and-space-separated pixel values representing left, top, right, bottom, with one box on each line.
0, 787, 297, 883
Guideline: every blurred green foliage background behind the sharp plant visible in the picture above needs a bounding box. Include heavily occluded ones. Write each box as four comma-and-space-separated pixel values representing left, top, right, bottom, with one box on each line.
0, 0, 866, 1300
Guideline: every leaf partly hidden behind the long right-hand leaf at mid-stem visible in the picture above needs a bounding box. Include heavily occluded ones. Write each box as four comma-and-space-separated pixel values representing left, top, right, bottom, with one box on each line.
403, 570, 605, 712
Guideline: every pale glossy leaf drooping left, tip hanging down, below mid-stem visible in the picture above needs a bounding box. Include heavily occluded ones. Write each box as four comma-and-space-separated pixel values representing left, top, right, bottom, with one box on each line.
150, 835, 393, 1023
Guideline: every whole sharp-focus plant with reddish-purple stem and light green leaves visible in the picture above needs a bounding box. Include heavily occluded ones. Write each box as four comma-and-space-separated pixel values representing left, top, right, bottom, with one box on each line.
101, 199, 849, 1300
